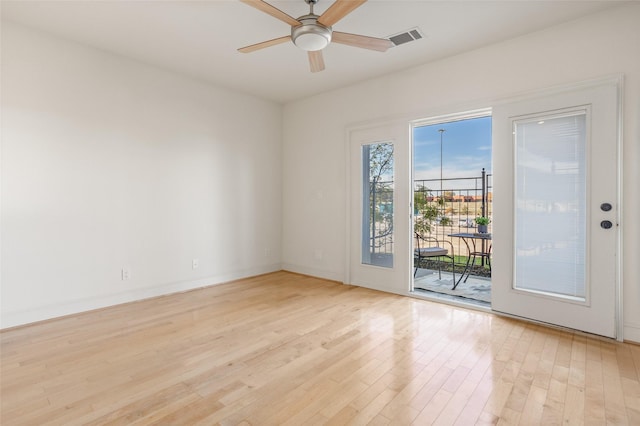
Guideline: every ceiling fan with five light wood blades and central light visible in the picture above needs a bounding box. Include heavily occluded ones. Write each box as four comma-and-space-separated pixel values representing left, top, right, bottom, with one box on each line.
238, 0, 393, 72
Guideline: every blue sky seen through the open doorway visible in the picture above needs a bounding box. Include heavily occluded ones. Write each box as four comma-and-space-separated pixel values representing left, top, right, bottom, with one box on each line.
413, 117, 492, 189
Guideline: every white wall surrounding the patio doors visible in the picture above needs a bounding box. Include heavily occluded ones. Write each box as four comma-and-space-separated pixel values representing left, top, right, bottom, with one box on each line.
283, 4, 640, 342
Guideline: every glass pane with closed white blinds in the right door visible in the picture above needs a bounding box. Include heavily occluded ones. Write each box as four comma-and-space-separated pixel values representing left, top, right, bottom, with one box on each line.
513, 110, 587, 302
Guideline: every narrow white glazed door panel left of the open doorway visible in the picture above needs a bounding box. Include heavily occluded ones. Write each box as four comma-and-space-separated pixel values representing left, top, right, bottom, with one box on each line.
347, 124, 411, 293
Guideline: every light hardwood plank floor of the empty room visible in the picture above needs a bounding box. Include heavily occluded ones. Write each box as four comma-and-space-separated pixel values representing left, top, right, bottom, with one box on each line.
0, 272, 640, 426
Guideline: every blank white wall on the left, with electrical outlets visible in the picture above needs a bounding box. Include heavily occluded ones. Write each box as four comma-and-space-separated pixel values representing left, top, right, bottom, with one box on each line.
1, 23, 282, 327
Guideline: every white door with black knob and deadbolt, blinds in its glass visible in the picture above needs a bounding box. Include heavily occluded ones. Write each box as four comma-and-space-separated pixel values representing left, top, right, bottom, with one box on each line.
492, 80, 619, 337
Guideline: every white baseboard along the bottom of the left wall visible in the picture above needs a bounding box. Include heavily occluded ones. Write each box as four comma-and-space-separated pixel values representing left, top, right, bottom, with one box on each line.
0, 263, 282, 329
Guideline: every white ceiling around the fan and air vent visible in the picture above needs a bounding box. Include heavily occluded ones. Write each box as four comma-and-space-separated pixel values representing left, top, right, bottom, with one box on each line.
1, 0, 626, 102
